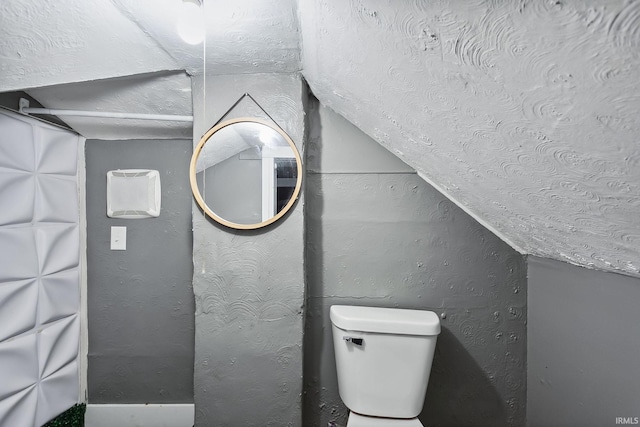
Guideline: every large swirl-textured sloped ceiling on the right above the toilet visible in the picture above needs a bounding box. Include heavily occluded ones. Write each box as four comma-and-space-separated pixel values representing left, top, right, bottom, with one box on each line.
301, 0, 640, 276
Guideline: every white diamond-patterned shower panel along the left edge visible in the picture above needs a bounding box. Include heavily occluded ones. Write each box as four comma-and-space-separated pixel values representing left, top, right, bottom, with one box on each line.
0, 110, 80, 427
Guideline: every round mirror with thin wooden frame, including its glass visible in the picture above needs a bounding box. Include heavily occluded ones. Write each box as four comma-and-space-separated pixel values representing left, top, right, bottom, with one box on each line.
189, 118, 302, 230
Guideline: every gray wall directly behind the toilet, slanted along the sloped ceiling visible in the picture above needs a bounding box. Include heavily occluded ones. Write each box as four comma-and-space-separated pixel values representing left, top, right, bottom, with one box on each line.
304, 104, 527, 427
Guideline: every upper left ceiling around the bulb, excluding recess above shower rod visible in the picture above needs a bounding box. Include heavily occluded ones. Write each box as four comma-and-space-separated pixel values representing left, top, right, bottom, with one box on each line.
0, 0, 300, 92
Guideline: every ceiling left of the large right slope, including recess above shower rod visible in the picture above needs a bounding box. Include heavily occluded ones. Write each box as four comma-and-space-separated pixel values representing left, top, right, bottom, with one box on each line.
0, 0, 300, 139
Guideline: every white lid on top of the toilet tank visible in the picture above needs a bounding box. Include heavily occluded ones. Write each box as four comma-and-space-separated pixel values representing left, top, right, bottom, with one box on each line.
329, 305, 440, 335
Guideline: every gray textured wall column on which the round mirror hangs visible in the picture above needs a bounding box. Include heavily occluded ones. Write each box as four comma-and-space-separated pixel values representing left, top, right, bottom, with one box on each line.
193, 74, 306, 427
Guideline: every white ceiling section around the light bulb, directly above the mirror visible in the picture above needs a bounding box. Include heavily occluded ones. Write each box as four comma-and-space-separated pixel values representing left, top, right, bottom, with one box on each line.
107, 0, 300, 74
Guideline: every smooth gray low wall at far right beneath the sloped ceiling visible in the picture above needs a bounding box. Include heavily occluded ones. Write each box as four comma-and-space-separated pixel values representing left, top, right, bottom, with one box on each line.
527, 257, 640, 427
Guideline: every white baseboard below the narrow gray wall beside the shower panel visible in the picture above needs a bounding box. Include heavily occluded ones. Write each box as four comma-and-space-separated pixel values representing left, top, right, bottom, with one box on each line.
84, 403, 195, 427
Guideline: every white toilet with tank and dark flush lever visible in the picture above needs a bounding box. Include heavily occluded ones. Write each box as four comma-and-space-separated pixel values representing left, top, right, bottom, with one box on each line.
330, 305, 440, 427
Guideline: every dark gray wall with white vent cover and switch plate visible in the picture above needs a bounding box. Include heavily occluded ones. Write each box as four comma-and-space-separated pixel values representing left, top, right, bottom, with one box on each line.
86, 140, 195, 403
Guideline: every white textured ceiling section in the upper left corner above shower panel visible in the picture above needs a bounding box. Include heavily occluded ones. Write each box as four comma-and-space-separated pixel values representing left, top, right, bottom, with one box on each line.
0, 0, 180, 92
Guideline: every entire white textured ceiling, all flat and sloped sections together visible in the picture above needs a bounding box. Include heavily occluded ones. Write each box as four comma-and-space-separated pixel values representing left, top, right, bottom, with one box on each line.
0, 0, 640, 277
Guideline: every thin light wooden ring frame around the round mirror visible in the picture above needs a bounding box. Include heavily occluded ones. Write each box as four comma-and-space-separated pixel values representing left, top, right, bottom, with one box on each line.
189, 117, 302, 230
